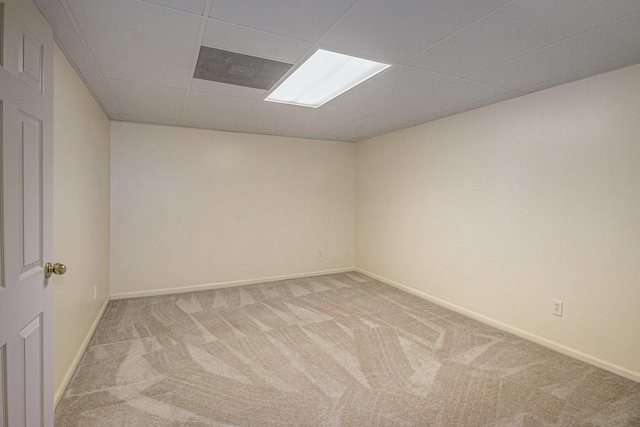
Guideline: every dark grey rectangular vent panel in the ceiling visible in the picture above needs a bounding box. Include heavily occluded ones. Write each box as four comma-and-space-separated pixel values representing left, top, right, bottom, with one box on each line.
193, 46, 293, 90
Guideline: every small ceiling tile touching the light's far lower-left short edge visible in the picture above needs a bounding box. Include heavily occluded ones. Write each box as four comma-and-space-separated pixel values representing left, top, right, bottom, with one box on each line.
236, 101, 316, 132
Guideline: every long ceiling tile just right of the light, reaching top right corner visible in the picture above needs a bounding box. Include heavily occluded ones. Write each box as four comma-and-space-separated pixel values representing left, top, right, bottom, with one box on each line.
407, 0, 640, 77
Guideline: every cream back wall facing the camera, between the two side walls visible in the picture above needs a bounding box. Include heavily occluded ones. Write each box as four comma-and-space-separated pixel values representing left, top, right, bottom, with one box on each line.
111, 122, 355, 298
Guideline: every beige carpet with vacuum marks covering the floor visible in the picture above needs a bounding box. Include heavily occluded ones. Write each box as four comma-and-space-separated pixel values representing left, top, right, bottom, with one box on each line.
56, 273, 640, 427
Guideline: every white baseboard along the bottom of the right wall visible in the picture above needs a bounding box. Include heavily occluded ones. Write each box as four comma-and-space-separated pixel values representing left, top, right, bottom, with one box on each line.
355, 267, 640, 382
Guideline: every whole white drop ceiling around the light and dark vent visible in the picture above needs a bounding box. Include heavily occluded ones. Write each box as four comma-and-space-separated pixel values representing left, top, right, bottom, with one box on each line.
35, 0, 640, 141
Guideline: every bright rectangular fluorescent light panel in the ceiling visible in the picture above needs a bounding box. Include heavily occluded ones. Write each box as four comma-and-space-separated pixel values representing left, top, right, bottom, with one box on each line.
265, 49, 390, 108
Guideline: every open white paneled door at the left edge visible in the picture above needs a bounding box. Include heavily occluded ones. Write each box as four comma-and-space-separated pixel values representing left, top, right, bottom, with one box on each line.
0, 0, 54, 427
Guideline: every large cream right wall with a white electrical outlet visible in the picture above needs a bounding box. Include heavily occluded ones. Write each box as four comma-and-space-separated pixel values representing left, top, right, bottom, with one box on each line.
356, 66, 640, 381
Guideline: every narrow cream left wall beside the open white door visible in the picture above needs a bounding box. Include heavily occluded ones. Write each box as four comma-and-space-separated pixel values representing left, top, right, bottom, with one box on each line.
53, 46, 110, 404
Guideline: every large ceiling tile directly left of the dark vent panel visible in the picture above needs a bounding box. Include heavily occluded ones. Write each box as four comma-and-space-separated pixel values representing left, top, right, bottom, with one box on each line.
67, 0, 201, 88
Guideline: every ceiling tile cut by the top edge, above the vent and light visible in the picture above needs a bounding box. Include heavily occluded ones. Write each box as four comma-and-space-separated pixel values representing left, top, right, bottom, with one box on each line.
209, 0, 356, 42
